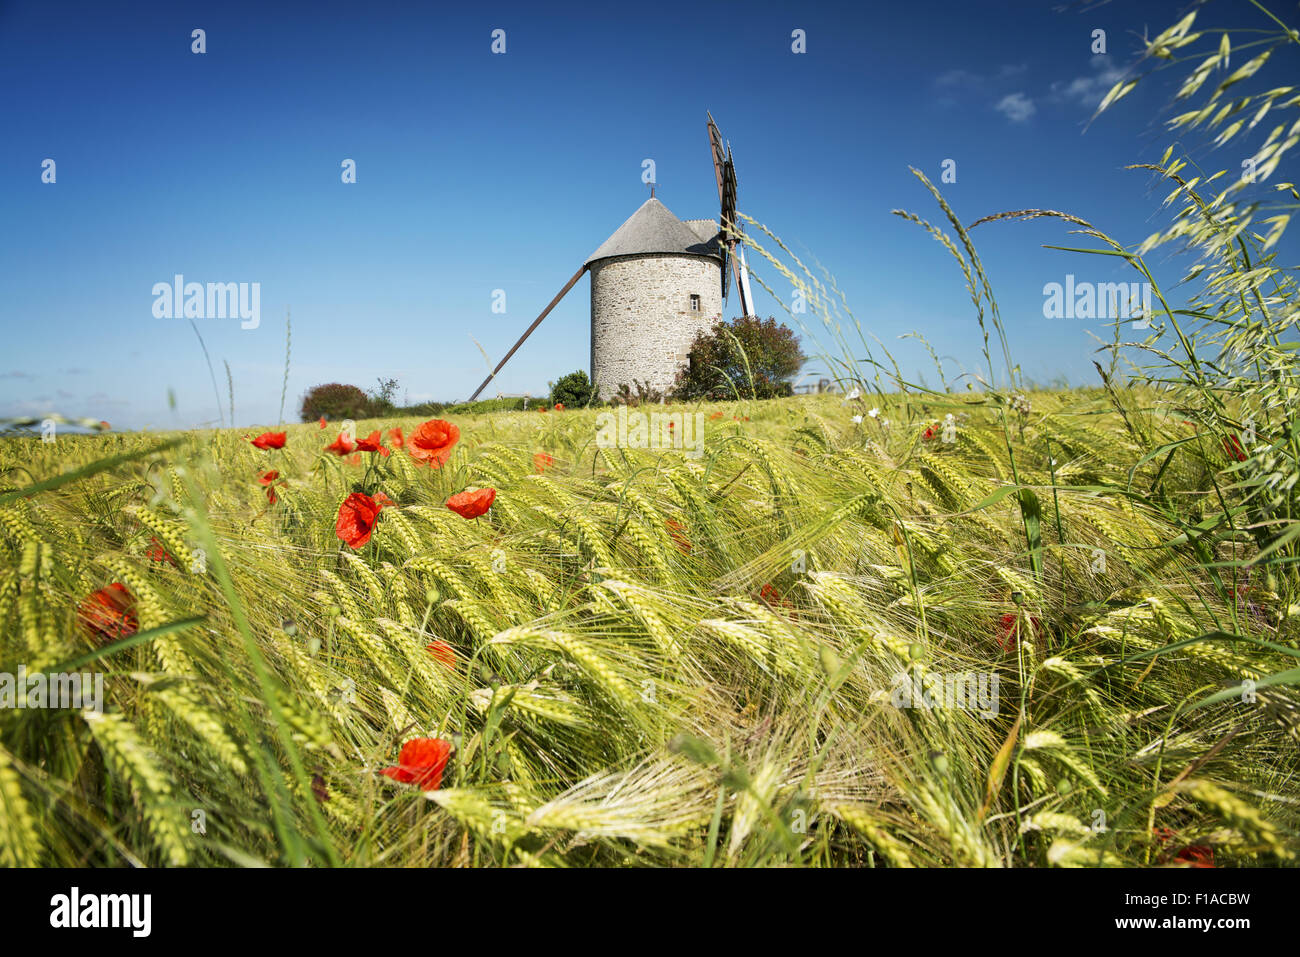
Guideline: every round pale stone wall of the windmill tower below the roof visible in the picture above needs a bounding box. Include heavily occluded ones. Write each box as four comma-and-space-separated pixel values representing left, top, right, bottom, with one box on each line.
590, 255, 723, 399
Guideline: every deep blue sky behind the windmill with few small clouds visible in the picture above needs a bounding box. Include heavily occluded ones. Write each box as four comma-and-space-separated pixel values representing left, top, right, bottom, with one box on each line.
0, 0, 1294, 428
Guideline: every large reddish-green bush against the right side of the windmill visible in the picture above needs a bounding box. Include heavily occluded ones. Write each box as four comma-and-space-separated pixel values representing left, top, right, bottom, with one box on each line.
672, 316, 805, 402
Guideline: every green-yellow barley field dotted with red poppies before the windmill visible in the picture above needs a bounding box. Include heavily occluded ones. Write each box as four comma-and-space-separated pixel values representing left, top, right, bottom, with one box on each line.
0, 390, 1297, 867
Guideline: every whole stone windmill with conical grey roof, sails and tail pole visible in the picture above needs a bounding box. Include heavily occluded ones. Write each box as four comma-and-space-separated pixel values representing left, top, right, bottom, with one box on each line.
469, 116, 753, 402
